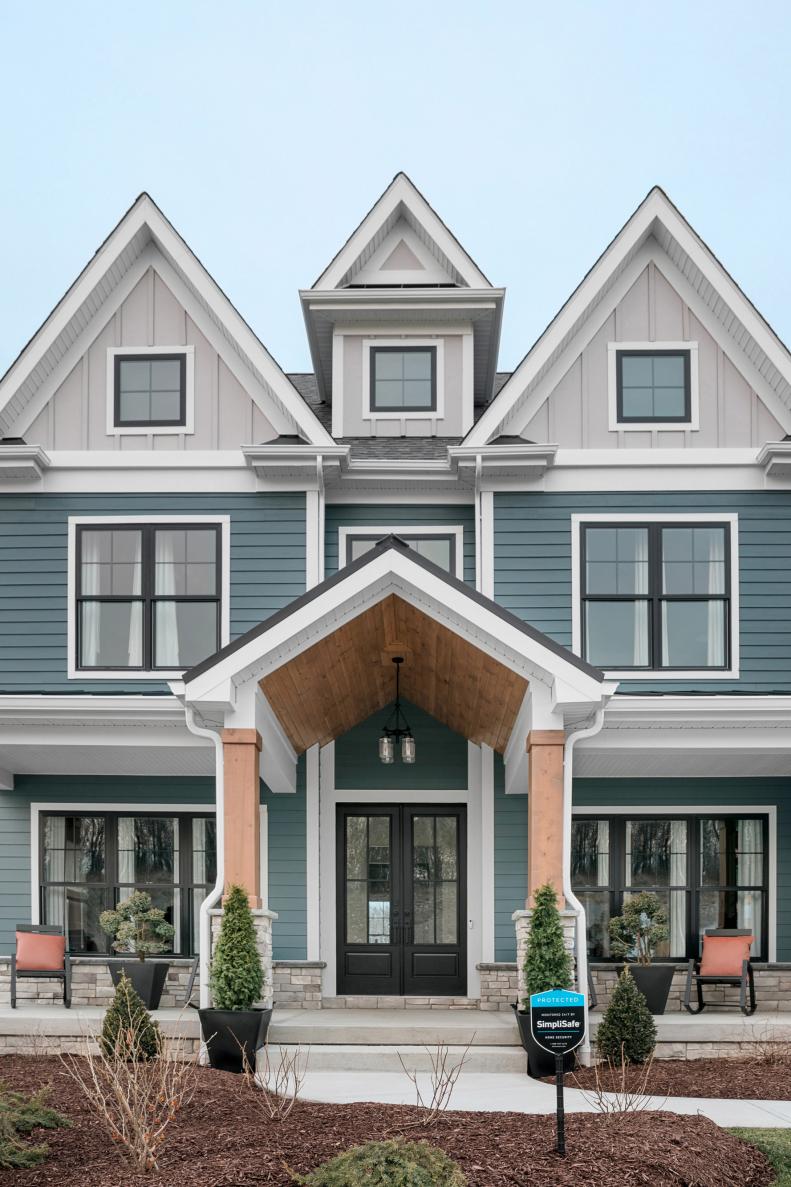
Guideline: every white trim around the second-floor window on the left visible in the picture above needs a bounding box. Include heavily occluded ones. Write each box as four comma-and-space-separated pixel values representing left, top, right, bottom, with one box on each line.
67, 514, 230, 683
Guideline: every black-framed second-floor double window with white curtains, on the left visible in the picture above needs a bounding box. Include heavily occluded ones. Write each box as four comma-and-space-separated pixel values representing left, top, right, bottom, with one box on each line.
76, 521, 222, 672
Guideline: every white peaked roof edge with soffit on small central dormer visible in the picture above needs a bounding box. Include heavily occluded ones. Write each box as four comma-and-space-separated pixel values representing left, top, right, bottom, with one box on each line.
312, 173, 492, 290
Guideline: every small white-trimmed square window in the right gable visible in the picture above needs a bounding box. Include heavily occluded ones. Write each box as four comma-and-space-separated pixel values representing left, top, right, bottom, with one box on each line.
609, 342, 698, 430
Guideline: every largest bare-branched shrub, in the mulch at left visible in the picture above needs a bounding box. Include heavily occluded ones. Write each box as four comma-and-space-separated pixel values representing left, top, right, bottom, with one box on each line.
59, 1020, 197, 1170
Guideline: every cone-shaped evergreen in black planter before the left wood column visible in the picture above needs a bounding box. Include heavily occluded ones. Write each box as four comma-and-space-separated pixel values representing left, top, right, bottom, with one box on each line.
198, 887, 272, 1073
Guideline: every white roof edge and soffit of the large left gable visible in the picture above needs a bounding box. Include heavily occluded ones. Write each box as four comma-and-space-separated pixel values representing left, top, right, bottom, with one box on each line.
0, 192, 333, 445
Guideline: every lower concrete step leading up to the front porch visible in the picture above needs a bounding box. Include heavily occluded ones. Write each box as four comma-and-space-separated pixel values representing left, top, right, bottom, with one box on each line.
258, 1042, 526, 1074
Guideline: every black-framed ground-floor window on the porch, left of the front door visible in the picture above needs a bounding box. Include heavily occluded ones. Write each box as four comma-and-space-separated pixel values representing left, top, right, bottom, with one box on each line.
39, 808, 217, 956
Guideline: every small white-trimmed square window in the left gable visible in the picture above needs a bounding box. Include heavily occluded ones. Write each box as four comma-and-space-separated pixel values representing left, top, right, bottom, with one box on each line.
107, 347, 194, 433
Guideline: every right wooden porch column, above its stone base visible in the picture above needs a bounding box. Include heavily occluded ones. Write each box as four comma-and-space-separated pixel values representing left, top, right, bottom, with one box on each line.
527, 730, 565, 907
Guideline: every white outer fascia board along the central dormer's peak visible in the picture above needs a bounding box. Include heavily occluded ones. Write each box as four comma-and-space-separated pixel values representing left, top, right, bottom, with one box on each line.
312, 173, 489, 288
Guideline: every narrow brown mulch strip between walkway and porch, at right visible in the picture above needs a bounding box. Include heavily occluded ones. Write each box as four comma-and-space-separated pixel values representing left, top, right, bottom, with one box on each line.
562, 1058, 791, 1100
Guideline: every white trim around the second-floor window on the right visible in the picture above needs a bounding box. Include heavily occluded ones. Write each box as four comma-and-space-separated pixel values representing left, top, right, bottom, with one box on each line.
571, 512, 739, 684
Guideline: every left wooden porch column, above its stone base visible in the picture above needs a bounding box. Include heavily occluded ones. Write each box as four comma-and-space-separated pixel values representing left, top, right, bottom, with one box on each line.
222, 730, 261, 907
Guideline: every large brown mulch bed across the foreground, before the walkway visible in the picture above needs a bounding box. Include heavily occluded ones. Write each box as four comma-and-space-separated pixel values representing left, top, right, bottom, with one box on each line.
0, 1056, 773, 1187
